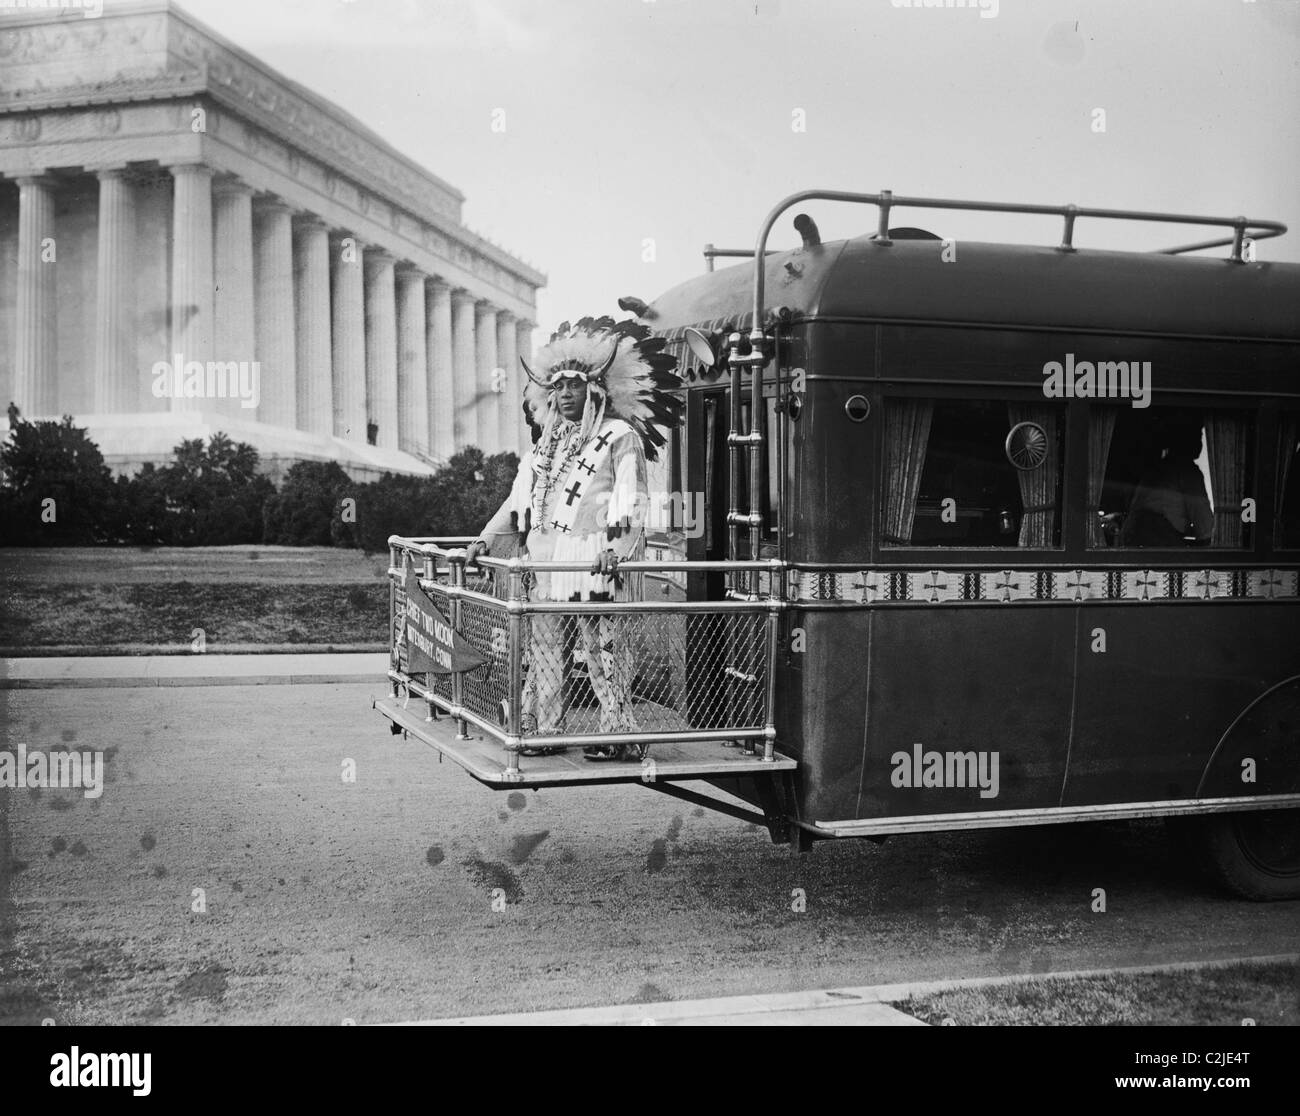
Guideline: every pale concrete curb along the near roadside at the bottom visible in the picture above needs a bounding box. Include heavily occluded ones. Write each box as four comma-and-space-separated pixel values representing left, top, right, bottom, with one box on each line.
381, 953, 1300, 1026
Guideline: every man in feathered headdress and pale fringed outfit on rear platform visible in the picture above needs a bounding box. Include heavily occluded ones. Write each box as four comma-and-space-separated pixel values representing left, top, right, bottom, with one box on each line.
468, 317, 681, 760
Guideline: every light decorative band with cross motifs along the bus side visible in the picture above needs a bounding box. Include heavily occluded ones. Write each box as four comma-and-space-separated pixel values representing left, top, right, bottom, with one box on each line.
790, 570, 1300, 605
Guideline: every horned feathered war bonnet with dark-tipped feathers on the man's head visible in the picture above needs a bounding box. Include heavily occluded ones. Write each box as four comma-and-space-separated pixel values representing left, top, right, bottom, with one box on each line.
519, 316, 683, 460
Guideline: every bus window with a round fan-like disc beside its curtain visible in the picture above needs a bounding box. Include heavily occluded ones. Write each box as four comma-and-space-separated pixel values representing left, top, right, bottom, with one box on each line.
883, 398, 1065, 549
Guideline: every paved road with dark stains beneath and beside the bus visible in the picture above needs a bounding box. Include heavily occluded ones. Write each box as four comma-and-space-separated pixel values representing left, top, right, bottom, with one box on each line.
0, 684, 1300, 1024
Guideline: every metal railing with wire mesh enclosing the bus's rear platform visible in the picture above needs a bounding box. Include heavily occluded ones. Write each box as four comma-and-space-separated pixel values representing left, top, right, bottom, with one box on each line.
387, 536, 787, 779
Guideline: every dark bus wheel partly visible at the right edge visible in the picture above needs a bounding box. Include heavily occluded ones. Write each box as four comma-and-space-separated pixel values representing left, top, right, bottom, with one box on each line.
1196, 810, 1300, 900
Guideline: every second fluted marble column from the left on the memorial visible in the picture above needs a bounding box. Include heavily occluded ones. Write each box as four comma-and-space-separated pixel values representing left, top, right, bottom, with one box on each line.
92, 166, 137, 415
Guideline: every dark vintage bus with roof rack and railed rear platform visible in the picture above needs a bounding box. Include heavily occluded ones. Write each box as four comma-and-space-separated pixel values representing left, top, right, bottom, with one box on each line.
377, 190, 1300, 899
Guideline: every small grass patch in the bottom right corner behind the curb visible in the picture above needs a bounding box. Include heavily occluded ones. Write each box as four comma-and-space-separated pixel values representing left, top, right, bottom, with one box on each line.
894, 964, 1300, 1026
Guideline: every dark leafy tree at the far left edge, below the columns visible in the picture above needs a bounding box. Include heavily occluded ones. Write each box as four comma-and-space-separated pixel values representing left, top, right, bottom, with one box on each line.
0, 405, 117, 546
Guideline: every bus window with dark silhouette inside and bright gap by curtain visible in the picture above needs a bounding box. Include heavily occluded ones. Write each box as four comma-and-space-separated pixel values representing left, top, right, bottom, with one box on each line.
1088, 406, 1255, 549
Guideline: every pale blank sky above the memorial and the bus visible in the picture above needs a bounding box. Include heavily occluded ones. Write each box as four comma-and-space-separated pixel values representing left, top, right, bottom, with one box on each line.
157, 0, 1300, 330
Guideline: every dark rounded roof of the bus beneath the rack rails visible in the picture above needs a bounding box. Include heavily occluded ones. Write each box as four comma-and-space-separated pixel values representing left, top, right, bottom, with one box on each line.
649, 237, 1300, 341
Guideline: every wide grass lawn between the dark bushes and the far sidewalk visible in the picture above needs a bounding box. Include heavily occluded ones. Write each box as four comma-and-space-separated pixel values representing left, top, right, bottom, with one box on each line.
0, 546, 389, 654
